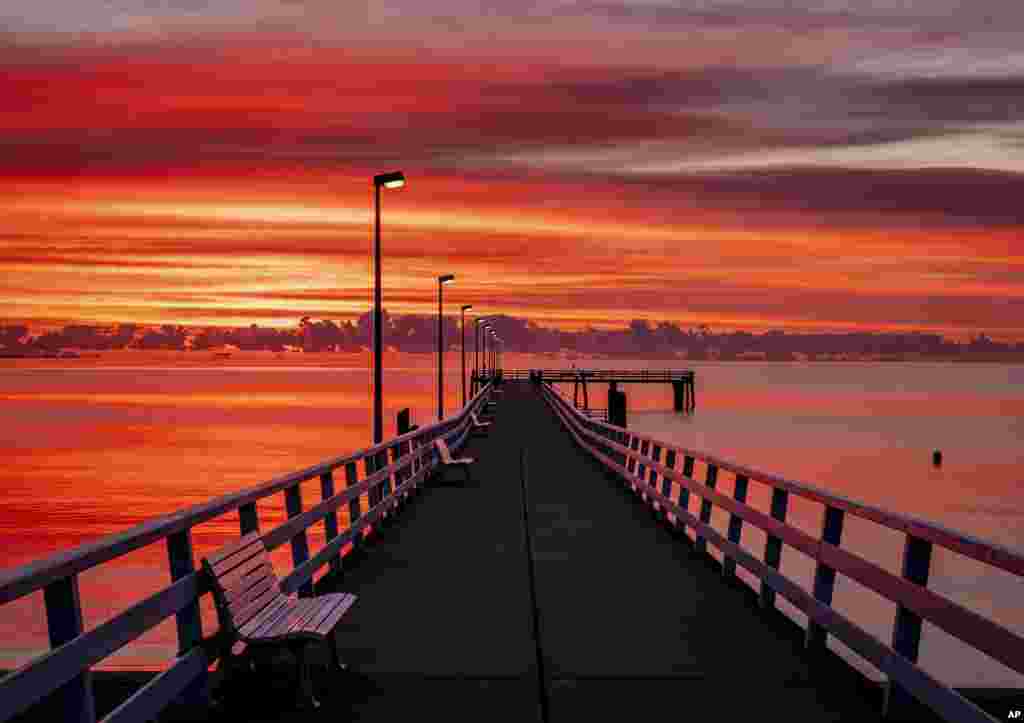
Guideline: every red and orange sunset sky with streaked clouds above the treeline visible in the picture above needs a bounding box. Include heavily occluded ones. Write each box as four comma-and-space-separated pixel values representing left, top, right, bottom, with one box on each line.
0, 0, 1024, 340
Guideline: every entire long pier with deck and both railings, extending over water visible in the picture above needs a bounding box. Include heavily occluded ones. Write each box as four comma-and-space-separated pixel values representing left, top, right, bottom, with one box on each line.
0, 370, 1024, 723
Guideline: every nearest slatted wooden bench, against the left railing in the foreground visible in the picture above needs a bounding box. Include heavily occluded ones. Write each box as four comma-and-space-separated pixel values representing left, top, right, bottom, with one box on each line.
203, 533, 355, 708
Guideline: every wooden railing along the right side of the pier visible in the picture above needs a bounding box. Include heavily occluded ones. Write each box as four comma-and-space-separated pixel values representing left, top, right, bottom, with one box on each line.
541, 384, 1024, 723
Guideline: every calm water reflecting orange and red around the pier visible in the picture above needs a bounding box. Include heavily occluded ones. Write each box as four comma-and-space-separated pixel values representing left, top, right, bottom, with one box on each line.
0, 354, 1024, 687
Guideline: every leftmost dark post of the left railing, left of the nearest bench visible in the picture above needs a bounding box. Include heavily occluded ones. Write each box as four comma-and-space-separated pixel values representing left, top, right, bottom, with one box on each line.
43, 575, 96, 723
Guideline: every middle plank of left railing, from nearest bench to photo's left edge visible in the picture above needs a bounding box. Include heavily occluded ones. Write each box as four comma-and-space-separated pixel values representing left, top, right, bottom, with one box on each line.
0, 575, 203, 720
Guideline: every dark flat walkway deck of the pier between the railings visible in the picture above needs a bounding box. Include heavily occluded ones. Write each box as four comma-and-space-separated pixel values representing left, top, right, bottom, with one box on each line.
172, 383, 901, 721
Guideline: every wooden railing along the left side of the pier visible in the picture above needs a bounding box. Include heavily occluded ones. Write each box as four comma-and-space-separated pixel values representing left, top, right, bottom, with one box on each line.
0, 384, 492, 723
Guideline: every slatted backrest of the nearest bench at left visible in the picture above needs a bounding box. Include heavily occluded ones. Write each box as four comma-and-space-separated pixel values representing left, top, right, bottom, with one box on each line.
203, 533, 282, 631
